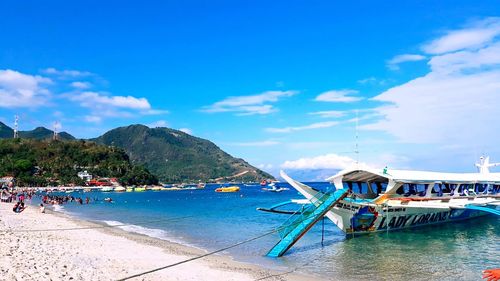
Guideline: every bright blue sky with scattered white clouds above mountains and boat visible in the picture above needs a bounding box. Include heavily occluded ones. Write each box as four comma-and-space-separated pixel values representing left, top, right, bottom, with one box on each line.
0, 1, 500, 173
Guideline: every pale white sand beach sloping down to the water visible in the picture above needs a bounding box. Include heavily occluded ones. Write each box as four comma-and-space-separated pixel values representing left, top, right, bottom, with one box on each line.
0, 203, 310, 281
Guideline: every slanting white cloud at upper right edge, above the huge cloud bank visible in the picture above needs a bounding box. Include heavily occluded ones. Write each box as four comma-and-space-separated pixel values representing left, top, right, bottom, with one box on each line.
422, 17, 500, 55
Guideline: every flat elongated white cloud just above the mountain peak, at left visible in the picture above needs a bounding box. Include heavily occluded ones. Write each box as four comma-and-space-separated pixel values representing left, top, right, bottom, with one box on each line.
67, 92, 151, 110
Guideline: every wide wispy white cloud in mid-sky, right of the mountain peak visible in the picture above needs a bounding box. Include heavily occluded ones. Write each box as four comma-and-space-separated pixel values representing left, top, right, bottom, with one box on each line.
202, 91, 298, 115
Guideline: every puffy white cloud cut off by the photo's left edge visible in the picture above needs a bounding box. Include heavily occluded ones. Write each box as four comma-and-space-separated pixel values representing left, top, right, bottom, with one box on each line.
0, 69, 52, 107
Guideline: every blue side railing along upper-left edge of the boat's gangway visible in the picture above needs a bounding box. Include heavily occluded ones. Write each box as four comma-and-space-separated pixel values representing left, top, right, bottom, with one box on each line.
277, 189, 331, 239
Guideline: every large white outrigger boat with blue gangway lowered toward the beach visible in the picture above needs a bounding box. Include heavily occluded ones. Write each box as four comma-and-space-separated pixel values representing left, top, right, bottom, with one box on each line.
261, 157, 500, 257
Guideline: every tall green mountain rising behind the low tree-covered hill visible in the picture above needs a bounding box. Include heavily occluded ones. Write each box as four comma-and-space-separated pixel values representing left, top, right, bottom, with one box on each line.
93, 125, 274, 182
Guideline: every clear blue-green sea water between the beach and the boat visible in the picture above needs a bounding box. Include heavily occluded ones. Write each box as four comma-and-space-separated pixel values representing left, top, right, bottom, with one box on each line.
45, 183, 500, 280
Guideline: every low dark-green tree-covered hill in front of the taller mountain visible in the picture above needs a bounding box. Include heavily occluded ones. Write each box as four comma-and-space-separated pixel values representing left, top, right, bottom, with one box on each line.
0, 138, 158, 186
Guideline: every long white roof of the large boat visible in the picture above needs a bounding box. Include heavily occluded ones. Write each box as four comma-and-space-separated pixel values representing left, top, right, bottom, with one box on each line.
327, 166, 500, 183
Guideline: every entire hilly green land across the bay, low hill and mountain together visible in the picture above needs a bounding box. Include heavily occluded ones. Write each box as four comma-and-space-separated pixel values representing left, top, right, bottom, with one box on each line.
0, 122, 274, 186
